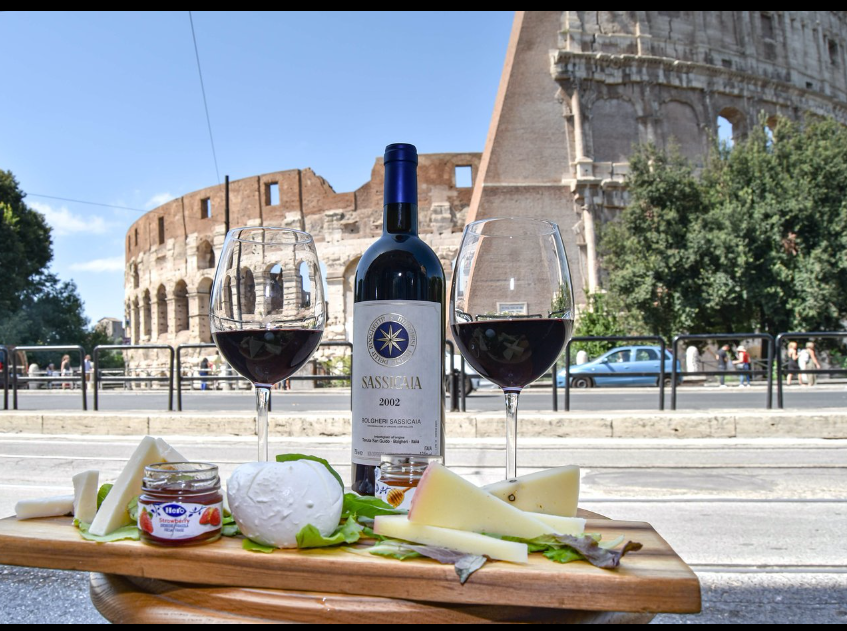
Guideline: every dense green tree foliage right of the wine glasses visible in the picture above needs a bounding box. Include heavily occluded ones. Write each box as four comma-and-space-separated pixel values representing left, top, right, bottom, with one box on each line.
601, 115, 847, 336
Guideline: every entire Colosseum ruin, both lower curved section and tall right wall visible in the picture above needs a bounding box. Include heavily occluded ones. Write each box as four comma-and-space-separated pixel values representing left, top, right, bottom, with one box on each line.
126, 11, 847, 358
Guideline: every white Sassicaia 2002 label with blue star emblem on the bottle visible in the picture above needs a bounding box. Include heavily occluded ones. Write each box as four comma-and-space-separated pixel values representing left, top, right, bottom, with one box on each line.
352, 300, 444, 466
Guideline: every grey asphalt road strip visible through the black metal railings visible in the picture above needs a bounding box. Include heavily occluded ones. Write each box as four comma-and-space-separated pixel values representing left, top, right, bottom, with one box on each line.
9, 384, 847, 412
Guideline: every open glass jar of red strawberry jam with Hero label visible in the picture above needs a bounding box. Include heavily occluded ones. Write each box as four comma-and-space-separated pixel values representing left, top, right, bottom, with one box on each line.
138, 462, 223, 546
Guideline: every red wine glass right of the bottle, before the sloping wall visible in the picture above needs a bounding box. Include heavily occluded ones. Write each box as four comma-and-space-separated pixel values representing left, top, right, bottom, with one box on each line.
450, 218, 573, 479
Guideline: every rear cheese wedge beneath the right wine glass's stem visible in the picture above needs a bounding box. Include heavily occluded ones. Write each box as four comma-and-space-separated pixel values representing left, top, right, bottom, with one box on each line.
482, 465, 579, 517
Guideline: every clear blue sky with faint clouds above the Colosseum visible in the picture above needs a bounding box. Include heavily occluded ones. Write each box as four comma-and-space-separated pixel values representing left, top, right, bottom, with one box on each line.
0, 11, 512, 320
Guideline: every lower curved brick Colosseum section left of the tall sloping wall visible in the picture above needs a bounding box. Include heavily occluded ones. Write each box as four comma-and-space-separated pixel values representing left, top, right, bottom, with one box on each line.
125, 153, 481, 358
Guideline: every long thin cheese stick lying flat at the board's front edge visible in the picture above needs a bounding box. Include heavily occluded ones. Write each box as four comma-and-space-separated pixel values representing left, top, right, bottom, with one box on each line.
374, 515, 527, 563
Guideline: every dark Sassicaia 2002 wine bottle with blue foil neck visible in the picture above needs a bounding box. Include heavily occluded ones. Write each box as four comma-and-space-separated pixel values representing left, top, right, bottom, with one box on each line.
352, 143, 445, 495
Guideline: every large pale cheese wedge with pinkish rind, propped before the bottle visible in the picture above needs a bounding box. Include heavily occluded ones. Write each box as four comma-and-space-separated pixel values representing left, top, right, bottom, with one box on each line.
409, 463, 555, 539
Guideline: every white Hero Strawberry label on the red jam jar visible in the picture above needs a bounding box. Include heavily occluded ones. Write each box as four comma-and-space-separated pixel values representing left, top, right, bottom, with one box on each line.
138, 502, 223, 540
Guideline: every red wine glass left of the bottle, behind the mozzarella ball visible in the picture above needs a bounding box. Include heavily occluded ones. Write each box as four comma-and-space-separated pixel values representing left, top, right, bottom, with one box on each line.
209, 227, 326, 462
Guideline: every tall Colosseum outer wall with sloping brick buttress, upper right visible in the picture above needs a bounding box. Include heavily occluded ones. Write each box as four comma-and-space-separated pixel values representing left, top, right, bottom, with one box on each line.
470, 11, 847, 302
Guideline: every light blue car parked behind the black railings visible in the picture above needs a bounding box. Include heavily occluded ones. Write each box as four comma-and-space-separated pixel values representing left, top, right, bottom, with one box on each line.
556, 346, 682, 388
